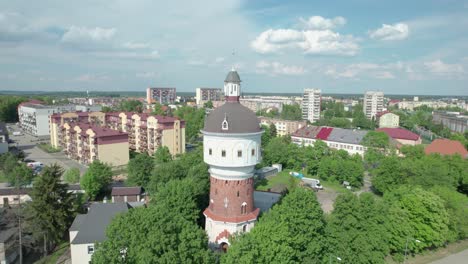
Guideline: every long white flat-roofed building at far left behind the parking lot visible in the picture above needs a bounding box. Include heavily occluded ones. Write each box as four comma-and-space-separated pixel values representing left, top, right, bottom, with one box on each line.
18, 103, 75, 136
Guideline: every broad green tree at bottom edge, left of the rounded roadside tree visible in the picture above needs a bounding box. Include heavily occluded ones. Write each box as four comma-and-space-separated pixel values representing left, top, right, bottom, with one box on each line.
325, 193, 389, 263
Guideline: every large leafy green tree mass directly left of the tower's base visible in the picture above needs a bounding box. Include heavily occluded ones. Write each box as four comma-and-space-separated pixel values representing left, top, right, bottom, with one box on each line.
92, 178, 215, 263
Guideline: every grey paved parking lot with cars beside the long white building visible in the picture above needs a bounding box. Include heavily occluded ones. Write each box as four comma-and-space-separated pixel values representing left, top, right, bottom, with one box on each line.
8, 124, 86, 173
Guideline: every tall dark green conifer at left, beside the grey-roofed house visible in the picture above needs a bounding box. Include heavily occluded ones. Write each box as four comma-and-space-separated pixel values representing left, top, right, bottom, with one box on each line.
28, 164, 75, 254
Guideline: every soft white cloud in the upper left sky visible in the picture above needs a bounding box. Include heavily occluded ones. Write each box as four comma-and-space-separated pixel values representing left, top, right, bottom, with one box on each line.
62, 26, 117, 43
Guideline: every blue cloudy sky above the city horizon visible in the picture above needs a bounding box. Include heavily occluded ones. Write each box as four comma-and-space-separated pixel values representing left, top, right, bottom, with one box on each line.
0, 0, 468, 95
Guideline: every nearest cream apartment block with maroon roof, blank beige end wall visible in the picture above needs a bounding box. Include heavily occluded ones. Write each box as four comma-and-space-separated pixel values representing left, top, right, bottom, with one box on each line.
54, 122, 129, 166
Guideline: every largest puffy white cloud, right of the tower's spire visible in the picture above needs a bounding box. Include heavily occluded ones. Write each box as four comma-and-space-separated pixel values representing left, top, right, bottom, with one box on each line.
251, 29, 359, 56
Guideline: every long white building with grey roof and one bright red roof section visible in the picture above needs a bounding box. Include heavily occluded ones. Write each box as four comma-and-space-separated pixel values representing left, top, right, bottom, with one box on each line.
291, 126, 368, 156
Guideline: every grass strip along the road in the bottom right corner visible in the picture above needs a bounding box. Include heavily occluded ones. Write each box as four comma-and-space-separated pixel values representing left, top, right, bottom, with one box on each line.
385, 239, 468, 264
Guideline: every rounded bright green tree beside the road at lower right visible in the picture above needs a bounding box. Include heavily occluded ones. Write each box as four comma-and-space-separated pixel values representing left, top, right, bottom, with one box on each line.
384, 186, 450, 253
